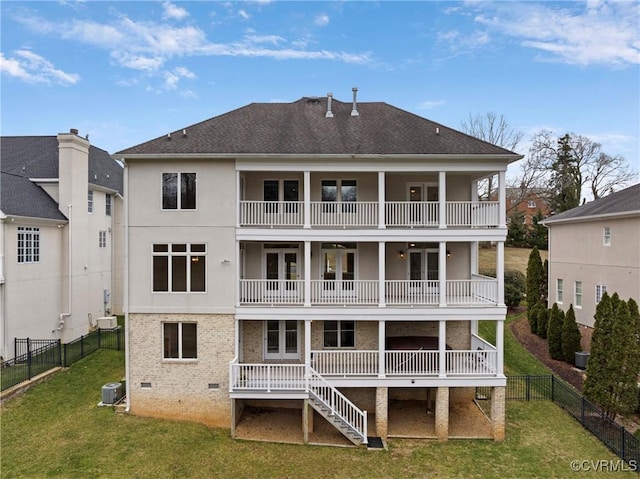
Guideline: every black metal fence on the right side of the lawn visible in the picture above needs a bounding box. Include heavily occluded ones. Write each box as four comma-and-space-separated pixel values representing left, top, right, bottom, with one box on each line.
500, 375, 640, 467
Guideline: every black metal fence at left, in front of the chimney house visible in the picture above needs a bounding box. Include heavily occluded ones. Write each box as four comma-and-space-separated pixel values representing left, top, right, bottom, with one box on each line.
0, 327, 124, 391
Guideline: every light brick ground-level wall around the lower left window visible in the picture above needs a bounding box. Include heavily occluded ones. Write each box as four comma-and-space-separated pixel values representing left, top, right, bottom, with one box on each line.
129, 314, 234, 428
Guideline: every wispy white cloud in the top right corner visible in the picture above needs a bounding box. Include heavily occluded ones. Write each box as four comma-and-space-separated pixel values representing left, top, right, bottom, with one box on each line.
475, 1, 640, 65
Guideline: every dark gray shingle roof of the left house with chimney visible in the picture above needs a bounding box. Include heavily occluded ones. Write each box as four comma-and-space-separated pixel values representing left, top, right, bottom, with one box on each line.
0, 136, 122, 220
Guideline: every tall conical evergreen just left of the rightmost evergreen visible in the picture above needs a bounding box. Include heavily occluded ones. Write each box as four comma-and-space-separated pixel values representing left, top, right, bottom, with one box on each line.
582, 292, 613, 414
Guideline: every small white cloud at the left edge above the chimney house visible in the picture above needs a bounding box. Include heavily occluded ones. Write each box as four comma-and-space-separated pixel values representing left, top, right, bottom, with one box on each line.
0, 50, 80, 85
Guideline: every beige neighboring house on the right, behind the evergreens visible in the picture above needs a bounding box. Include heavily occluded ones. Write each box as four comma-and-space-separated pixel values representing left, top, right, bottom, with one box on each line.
542, 184, 640, 350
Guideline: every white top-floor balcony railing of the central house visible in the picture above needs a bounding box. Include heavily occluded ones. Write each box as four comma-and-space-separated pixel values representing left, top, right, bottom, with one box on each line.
239, 200, 500, 228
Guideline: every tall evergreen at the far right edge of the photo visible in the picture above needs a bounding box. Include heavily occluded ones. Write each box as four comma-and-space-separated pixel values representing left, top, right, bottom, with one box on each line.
606, 300, 638, 416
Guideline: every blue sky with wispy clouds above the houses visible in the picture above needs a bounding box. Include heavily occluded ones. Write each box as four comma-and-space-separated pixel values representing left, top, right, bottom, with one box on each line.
0, 1, 640, 176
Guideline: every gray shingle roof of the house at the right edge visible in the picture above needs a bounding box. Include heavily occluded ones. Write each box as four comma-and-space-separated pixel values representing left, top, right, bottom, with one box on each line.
542, 183, 640, 224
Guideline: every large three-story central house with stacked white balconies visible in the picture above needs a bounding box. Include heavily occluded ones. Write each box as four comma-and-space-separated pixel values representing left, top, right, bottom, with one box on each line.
113, 91, 521, 443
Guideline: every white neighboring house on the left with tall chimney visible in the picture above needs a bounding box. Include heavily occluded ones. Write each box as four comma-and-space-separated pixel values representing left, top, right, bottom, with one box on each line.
0, 130, 124, 359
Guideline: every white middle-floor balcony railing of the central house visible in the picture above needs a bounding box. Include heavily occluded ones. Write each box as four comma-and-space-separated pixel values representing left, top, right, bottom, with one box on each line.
239, 275, 498, 306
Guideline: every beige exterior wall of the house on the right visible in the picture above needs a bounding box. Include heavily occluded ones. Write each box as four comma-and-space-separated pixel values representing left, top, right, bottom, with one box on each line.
549, 217, 640, 327
